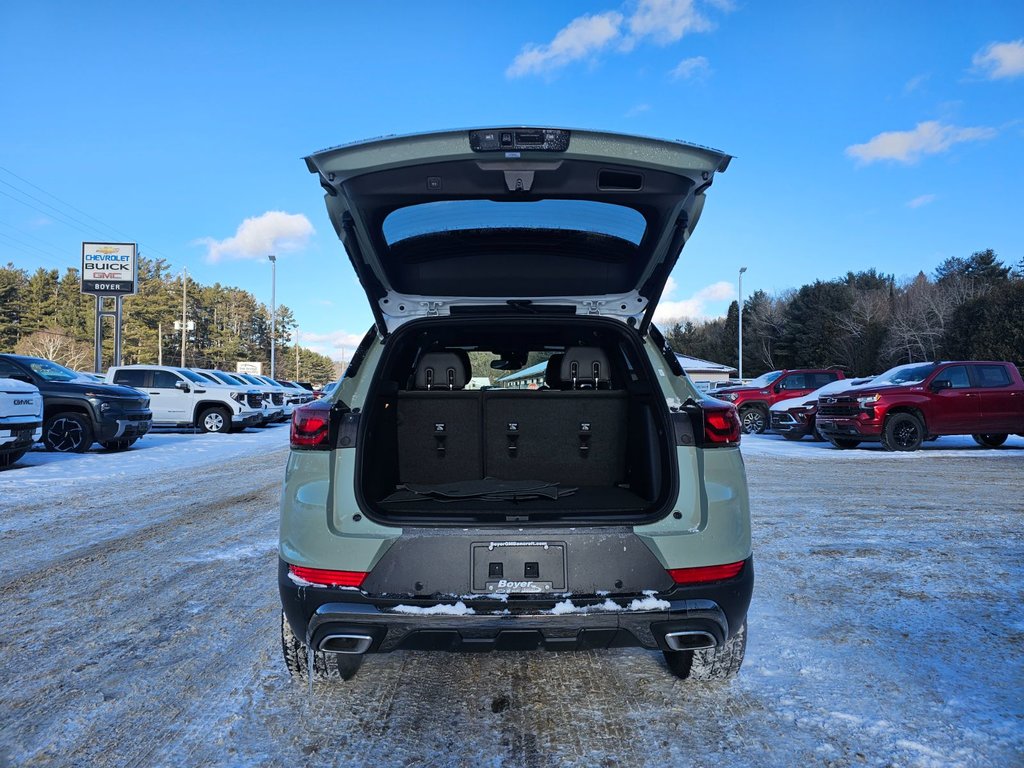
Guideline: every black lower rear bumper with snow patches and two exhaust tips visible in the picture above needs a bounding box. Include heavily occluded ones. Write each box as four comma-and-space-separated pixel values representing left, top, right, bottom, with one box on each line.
279, 560, 754, 653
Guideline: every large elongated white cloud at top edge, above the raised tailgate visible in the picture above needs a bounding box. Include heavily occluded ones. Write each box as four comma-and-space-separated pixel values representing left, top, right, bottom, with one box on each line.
505, 0, 733, 78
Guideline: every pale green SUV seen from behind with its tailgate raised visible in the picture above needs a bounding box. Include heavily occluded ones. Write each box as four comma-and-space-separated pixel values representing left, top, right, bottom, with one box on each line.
279, 128, 754, 681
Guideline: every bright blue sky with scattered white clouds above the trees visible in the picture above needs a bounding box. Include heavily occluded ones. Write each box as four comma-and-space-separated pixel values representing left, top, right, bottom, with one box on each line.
0, 0, 1024, 356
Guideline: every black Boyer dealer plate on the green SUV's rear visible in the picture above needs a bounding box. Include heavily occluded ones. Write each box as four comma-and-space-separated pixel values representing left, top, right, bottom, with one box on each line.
472, 541, 566, 595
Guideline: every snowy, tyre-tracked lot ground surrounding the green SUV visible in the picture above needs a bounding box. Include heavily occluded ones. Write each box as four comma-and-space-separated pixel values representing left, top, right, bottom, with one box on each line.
0, 427, 1024, 768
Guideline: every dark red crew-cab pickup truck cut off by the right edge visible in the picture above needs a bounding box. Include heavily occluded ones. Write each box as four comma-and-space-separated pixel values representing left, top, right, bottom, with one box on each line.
816, 360, 1024, 451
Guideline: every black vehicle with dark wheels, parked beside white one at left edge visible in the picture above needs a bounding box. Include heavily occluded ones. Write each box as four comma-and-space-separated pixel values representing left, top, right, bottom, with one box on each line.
0, 354, 153, 454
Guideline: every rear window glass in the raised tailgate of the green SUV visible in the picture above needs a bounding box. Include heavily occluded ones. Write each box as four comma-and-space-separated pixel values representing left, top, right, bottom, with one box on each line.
383, 200, 647, 245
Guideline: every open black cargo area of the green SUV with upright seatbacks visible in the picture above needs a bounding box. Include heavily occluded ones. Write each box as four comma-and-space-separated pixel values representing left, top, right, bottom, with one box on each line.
359, 319, 675, 523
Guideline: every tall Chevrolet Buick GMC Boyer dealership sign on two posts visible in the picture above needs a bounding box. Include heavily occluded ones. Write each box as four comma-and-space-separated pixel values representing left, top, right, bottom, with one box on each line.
82, 243, 138, 373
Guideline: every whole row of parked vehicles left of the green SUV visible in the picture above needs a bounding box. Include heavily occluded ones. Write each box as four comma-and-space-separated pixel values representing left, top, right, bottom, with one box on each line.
0, 354, 314, 469
